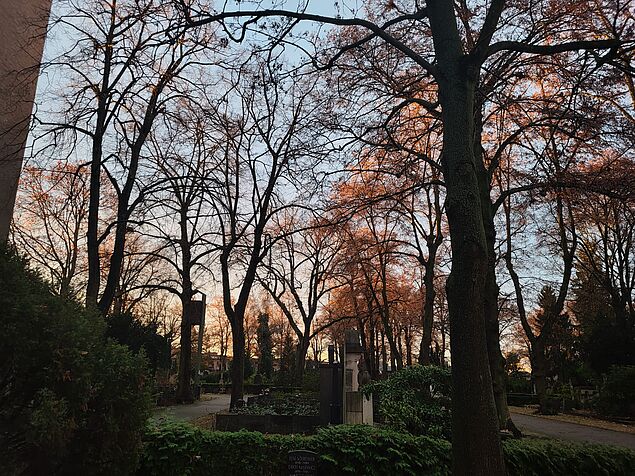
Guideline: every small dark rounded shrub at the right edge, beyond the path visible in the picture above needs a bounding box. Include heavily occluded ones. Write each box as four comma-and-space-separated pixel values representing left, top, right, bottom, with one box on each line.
596, 365, 635, 417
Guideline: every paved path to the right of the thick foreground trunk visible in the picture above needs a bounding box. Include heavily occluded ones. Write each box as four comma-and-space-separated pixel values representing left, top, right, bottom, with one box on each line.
512, 413, 635, 450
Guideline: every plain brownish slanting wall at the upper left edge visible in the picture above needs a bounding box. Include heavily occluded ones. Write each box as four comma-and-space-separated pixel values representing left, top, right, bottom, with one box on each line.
0, 0, 51, 242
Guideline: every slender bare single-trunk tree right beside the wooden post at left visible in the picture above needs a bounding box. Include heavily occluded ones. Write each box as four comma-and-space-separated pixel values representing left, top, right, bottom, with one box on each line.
139, 101, 217, 402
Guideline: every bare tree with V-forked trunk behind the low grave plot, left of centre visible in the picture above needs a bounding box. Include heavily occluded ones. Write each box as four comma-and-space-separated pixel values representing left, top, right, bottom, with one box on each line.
209, 61, 328, 406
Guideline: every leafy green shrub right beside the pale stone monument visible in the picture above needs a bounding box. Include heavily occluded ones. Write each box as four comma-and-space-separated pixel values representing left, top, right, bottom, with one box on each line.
362, 365, 452, 439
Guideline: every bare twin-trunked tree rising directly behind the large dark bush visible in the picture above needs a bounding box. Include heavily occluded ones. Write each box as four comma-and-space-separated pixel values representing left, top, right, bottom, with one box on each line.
36, 0, 217, 314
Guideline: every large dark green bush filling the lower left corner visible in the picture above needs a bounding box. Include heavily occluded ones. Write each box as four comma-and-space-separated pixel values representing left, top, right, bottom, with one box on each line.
0, 249, 149, 475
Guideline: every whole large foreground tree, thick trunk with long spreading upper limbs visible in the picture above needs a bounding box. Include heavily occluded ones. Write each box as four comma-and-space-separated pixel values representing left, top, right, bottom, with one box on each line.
181, 0, 633, 475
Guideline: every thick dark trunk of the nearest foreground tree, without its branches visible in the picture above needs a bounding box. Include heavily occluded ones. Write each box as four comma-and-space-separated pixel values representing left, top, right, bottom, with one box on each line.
427, 0, 505, 476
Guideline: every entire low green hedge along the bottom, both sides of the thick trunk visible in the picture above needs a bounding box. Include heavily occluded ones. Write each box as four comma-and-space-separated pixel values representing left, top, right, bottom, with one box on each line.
138, 420, 635, 476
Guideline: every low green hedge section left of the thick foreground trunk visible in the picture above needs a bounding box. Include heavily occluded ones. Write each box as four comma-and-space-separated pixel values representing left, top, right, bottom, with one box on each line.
138, 421, 450, 476
